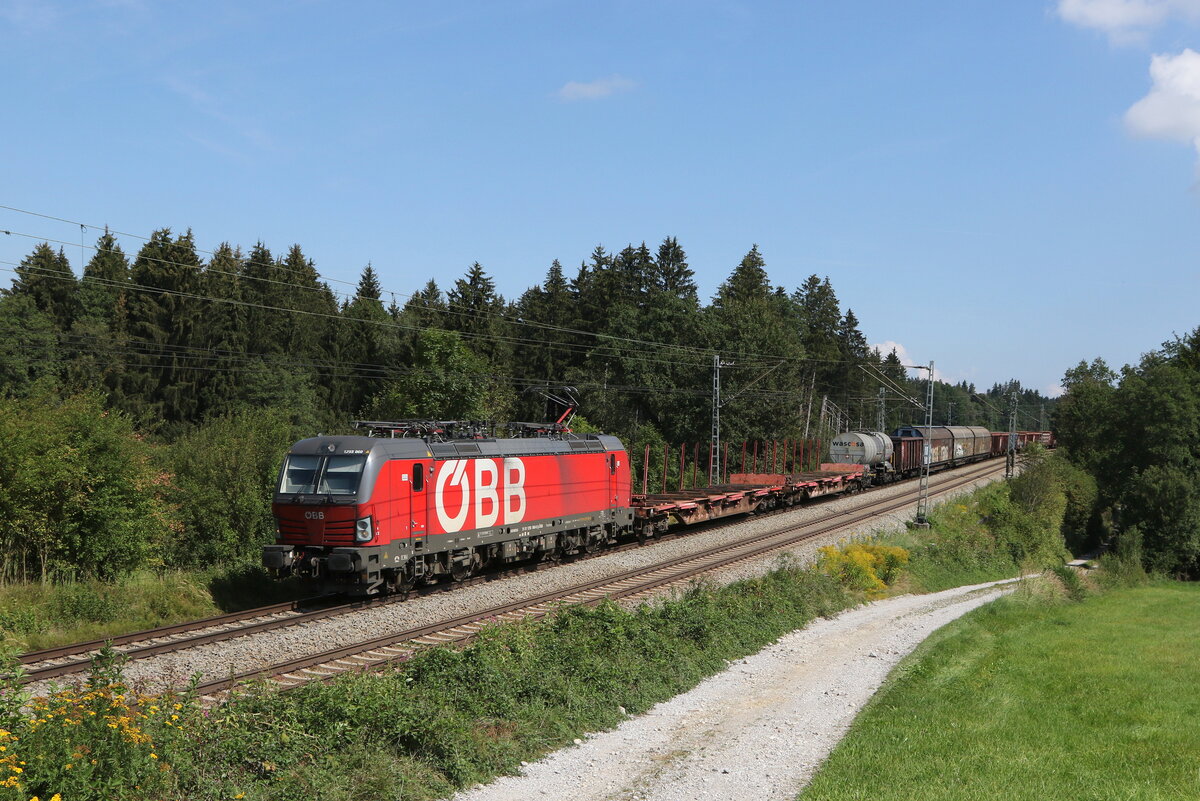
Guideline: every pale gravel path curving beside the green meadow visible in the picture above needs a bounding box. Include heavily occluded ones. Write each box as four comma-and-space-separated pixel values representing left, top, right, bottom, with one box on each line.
454, 575, 1012, 801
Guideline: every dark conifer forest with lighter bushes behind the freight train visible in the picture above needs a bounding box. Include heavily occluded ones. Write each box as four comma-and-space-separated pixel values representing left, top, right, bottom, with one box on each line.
0, 230, 1052, 579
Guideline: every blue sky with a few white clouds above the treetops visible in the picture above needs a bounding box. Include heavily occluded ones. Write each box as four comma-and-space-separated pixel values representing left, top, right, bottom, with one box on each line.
0, 0, 1200, 391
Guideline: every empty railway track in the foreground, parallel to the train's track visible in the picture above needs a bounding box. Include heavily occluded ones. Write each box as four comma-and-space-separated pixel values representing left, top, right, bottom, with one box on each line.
197, 463, 1003, 704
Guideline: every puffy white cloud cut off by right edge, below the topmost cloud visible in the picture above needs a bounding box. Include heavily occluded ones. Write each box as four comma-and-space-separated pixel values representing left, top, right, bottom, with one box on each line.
1124, 48, 1200, 163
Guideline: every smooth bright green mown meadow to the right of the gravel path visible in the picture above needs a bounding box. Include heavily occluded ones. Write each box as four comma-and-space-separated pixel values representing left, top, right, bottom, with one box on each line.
800, 583, 1200, 801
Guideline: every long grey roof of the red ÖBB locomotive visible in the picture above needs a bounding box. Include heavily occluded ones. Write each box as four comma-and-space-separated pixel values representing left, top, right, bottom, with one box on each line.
290, 434, 625, 459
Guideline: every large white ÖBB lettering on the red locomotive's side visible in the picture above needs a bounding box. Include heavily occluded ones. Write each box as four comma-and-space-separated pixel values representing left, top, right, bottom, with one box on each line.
433, 457, 526, 534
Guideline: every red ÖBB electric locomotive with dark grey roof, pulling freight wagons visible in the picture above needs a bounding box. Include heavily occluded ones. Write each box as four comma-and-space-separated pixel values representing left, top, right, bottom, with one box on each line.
263, 423, 634, 595
